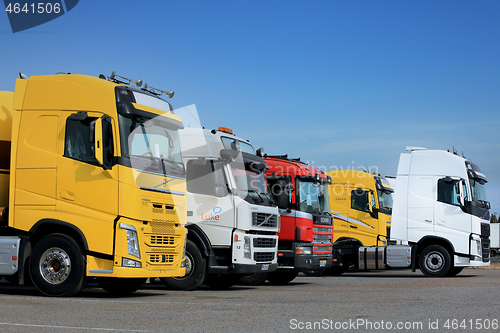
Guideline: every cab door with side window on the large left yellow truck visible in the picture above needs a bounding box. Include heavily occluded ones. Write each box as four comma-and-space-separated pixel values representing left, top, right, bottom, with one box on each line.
56, 111, 118, 255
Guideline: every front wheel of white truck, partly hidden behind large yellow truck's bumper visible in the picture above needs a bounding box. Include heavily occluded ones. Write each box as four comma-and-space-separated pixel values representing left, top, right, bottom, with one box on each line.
160, 239, 207, 290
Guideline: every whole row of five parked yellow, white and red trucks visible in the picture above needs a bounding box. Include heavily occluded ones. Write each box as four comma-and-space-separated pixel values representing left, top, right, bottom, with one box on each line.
0, 73, 493, 296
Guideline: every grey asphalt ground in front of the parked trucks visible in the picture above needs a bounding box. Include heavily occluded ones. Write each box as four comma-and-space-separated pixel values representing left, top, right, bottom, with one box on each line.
0, 269, 500, 333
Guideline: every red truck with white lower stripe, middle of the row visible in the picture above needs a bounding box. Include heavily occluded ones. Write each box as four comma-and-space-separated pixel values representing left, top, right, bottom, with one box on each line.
241, 150, 333, 284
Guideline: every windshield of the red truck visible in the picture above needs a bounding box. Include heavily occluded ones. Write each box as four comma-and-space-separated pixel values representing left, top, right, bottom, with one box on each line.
298, 181, 330, 214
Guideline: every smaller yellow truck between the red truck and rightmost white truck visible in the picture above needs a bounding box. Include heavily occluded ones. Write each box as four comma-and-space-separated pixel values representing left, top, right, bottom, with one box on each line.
326, 169, 394, 275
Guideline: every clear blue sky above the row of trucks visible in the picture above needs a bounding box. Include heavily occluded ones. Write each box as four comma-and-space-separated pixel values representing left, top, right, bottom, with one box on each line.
0, 0, 500, 212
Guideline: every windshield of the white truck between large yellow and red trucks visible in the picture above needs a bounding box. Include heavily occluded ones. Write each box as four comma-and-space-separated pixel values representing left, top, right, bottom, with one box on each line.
232, 168, 274, 206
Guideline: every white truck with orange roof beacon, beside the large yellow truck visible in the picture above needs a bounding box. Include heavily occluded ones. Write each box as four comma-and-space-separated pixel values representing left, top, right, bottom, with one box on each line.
162, 127, 280, 290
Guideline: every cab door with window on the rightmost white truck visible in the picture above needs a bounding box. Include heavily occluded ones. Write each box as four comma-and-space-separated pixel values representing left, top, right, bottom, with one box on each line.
434, 177, 472, 254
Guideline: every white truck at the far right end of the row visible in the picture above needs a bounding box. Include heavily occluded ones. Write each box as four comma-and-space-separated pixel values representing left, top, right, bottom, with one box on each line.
334, 147, 490, 277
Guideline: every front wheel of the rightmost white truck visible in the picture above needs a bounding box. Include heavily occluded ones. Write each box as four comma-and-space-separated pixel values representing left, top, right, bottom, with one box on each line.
419, 245, 451, 277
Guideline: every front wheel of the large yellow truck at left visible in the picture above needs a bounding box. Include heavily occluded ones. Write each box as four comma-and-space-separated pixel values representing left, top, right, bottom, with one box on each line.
29, 234, 87, 296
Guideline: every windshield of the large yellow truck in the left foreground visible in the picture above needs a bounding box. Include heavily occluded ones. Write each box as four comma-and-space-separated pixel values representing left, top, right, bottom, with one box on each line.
118, 115, 184, 177
